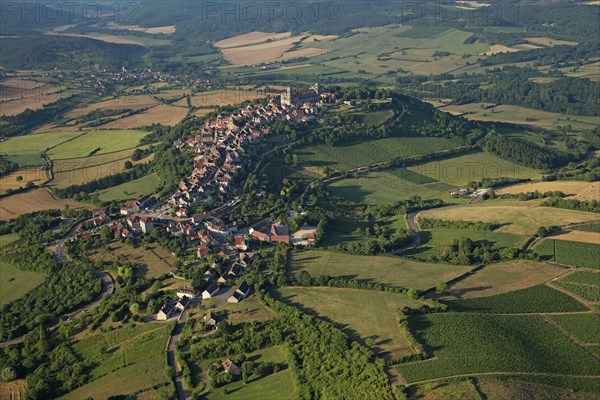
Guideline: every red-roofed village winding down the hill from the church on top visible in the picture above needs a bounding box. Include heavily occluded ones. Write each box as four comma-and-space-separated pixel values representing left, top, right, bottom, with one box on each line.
73, 83, 338, 320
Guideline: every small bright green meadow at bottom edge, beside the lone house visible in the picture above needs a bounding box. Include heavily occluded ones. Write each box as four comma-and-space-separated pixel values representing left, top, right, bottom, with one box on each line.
204, 346, 295, 400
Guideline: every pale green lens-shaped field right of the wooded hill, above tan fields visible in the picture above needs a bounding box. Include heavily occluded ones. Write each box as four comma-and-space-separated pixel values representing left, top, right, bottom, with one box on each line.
408, 152, 540, 187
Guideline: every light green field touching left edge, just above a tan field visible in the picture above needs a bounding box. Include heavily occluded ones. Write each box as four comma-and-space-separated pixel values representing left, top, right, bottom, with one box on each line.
0, 132, 82, 167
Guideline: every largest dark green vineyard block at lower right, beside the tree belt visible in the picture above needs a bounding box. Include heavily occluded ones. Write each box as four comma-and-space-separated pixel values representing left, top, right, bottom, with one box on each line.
397, 313, 600, 383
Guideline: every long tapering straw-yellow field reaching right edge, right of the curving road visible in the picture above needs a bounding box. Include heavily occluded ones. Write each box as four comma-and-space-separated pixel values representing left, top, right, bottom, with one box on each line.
419, 200, 600, 236
